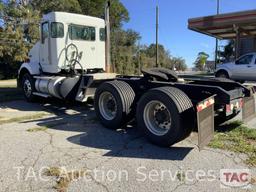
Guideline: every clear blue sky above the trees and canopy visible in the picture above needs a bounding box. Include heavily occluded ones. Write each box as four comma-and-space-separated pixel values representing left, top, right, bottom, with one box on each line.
121, 0, 256, 67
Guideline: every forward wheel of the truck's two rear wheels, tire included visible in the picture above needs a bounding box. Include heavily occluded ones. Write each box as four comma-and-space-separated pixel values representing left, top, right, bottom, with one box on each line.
95, 81, 135, 129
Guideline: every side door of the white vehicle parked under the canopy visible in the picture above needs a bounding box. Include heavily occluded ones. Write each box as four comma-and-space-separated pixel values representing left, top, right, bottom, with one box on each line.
232, 54, 254, 80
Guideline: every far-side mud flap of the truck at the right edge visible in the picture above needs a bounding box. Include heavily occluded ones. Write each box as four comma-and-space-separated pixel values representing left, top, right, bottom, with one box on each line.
242, 94, 256, 122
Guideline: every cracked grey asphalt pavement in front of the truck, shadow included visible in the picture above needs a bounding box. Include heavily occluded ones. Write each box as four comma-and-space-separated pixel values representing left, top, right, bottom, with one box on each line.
0, 101, 256, 192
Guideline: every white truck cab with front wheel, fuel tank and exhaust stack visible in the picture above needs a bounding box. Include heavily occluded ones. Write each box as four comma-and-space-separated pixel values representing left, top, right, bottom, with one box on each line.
18, 9, 115, 102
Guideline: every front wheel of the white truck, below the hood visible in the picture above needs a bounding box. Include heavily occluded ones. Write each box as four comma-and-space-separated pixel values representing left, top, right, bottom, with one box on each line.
21, 73, 36, 102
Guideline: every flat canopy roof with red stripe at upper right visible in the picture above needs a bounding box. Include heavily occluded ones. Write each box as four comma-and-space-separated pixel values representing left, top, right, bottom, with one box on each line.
188, 10, 256, 39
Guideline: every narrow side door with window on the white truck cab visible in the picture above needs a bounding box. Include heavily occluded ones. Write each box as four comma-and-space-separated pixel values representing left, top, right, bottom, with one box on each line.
39, 22, 50, 70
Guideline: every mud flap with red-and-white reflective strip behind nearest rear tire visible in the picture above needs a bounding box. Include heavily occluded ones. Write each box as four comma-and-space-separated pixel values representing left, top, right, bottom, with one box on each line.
196, 96, 214, 150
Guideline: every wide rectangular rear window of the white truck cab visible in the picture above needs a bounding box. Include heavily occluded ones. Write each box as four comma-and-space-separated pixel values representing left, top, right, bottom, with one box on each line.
68, 24, 95, 41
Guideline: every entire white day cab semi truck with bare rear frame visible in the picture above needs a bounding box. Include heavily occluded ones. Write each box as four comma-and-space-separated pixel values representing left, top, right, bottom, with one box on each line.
18, 4, 255, 148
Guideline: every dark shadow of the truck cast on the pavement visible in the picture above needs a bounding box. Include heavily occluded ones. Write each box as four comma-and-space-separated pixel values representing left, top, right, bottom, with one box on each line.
0, 99, 193, 160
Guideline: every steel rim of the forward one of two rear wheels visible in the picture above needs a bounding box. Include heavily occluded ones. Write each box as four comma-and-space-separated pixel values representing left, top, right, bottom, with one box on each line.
99, 91, 117, 121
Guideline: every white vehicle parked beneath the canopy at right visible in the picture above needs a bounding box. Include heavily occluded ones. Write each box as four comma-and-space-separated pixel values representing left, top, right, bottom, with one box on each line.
215, 53, 256, 81
